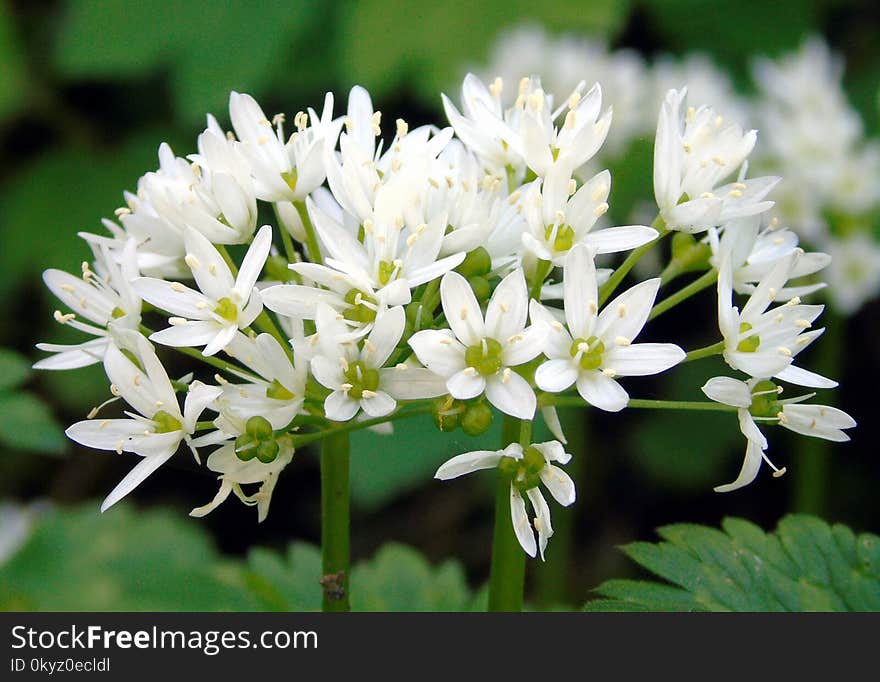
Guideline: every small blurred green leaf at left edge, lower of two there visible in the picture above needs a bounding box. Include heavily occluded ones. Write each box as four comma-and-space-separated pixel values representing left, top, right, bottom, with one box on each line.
0, 393, 67, 455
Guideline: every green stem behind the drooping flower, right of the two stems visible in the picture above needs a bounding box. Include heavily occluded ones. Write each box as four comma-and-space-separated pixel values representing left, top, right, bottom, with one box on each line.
489, 417, 531, 611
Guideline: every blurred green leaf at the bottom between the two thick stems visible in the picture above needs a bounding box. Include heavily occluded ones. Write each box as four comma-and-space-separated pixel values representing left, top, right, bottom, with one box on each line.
351, 543, 472, 611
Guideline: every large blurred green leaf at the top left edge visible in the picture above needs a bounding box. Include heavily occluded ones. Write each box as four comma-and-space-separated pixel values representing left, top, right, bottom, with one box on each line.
55, 0, 320, 121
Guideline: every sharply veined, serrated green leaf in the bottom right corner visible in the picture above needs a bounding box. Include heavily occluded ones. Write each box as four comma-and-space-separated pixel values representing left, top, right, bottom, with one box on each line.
585, 515, 880, 611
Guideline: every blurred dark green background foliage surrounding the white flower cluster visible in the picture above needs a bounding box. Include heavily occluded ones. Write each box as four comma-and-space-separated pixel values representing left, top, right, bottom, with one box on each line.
0, 0, 880, 609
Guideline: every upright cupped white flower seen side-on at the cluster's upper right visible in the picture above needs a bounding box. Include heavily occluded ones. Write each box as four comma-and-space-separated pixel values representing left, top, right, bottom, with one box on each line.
654, 89, 779, 232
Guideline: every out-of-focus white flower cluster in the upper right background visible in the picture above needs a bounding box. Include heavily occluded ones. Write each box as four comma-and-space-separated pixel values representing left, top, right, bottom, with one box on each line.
484, 26, 880, 315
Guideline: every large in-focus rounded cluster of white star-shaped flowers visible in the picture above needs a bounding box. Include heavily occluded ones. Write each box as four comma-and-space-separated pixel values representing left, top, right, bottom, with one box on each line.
37, 70, 853, 556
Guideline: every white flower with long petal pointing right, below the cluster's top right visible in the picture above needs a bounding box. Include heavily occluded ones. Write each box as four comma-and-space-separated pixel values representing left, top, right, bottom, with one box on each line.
522, 167, 657, 266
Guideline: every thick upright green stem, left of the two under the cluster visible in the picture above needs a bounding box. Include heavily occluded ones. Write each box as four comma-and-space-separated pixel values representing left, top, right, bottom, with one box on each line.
321, 433, 351, 611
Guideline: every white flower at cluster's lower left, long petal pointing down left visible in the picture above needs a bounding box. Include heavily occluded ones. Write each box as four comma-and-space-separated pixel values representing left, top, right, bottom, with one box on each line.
66, 335, 220, 511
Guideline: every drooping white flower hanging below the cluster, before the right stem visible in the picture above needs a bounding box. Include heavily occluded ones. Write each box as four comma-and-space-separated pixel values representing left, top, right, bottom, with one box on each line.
434, 440, 576, 559
